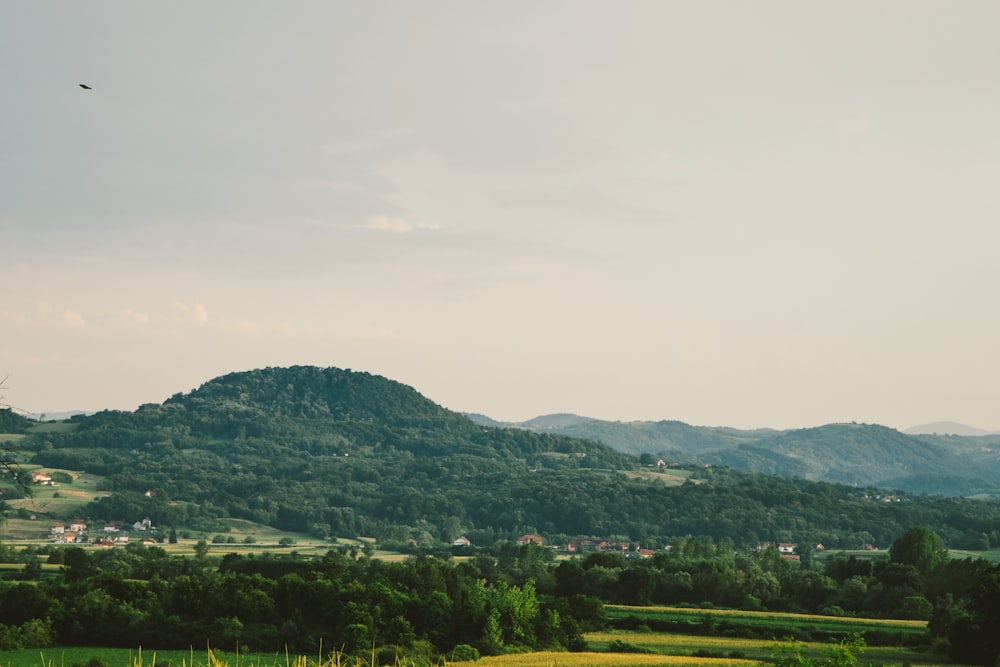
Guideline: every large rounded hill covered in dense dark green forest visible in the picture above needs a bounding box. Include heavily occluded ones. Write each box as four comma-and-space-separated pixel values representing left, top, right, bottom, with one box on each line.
11, 367, 1000, 548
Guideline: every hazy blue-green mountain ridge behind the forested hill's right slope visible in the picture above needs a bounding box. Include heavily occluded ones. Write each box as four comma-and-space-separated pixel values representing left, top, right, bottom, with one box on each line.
470, 414, 1000, 496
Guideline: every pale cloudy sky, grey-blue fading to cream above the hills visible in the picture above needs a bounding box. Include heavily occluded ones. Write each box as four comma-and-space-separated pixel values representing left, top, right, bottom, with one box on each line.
0, 0, 1000, 429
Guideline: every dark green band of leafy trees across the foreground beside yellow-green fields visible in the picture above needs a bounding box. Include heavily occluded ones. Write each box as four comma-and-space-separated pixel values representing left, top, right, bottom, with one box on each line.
0, 528, 1000, 665
